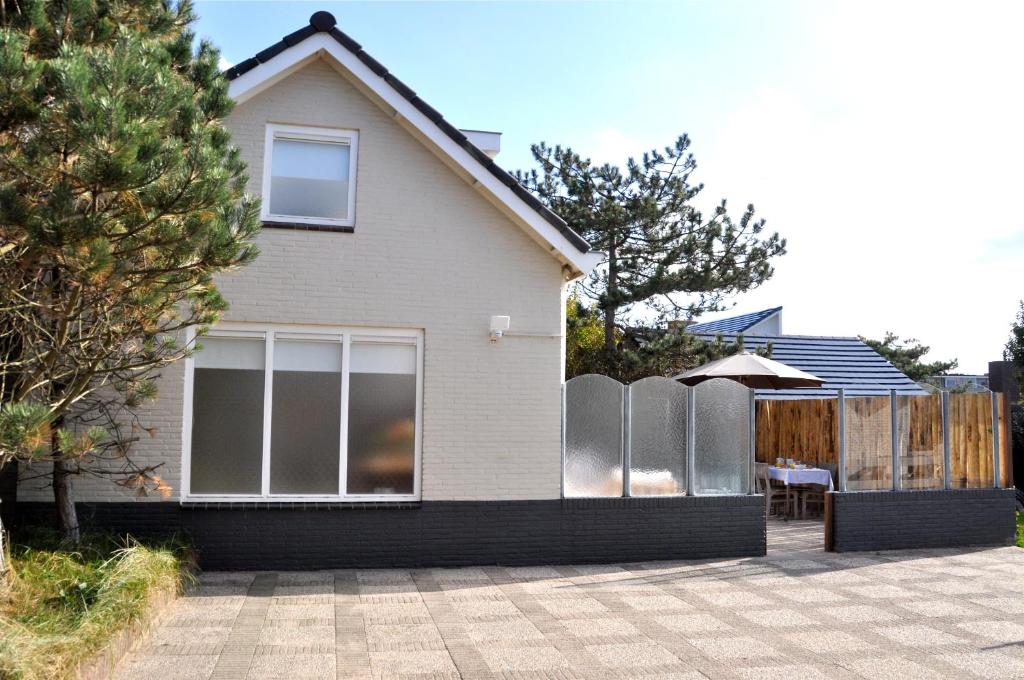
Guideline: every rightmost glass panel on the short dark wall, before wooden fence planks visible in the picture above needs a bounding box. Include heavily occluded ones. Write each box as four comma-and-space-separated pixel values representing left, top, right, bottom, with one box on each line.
949, 392, 994, 488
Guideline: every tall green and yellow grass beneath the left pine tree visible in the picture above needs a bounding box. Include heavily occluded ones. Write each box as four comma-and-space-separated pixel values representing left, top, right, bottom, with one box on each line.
0, 532, 190, 680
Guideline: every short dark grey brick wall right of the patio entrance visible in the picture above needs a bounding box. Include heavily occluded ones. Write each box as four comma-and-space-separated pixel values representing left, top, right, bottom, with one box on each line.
833, 488, 1017, 552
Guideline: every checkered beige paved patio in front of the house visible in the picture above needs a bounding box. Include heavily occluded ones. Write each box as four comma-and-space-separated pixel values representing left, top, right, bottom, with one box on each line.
117, 521, 1024, 680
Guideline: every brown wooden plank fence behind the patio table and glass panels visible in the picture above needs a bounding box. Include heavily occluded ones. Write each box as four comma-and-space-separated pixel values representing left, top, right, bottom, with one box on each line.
756, 392, 1012, 491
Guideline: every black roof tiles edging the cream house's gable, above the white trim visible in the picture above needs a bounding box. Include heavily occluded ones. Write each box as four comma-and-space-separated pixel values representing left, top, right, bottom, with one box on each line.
224, 11, 590, 253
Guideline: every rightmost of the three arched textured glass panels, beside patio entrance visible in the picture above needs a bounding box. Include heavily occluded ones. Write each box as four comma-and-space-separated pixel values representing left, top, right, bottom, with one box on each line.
693, 378, 751, 495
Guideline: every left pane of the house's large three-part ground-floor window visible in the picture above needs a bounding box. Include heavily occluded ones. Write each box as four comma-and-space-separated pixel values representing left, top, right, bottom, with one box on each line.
189, 338, 265, 495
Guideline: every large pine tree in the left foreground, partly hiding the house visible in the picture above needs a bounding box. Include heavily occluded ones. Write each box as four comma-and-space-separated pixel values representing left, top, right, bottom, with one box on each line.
0, 0, 259, 541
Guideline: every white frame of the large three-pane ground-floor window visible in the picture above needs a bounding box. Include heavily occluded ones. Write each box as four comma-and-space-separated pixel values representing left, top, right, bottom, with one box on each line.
180, 323, 423, 503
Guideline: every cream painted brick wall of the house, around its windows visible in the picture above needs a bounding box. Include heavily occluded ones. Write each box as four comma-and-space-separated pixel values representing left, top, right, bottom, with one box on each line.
19, 61, 562, 500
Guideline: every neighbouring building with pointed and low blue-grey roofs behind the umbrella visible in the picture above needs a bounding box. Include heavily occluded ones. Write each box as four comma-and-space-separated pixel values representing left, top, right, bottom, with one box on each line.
686, 307, 927, 399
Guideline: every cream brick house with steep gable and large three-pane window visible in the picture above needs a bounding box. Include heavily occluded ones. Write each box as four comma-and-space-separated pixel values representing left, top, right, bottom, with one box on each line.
18, 12, 679, 566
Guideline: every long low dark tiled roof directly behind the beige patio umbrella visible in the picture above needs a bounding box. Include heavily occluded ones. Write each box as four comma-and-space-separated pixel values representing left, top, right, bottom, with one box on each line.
687, 327, 928, 399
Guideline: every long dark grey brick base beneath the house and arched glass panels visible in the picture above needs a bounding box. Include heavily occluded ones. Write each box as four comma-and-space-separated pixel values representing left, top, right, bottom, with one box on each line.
16, 496, 766, 569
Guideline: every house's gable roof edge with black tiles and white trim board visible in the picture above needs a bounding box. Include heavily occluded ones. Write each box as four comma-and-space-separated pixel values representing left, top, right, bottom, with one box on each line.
224, 11, 601, 275
